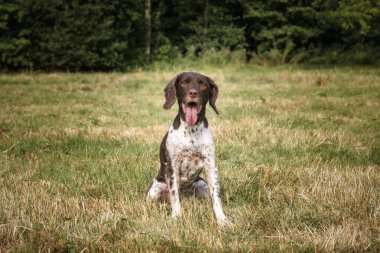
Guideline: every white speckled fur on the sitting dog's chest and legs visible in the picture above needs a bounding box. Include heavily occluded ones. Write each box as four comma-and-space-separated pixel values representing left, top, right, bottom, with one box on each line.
147, 119, 228, 225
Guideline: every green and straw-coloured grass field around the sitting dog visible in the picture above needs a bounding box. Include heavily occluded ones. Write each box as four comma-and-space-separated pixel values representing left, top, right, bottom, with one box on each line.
0, 66, 380, 252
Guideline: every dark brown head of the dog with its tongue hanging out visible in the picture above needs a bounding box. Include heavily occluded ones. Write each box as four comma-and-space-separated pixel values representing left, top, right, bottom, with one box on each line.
164, 72, 219, 126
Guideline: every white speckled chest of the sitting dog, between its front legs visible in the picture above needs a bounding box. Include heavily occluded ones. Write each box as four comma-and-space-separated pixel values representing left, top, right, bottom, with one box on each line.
166, 123, 215, 187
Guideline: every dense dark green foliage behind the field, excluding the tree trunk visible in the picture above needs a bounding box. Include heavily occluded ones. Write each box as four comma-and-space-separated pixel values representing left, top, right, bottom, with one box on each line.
0, 0, 380, 70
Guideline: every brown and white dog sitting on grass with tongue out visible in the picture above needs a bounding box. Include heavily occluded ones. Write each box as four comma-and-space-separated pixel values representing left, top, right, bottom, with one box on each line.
146, 72, 230, 226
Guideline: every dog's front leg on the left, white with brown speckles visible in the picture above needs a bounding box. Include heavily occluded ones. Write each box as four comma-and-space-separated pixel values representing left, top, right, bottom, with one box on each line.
166, 164, 181, 219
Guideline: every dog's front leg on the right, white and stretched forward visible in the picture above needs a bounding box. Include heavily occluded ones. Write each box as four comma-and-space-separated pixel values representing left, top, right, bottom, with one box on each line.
205, 158, 230, 226
